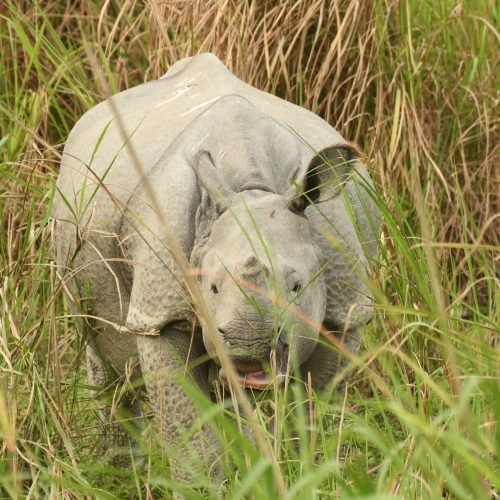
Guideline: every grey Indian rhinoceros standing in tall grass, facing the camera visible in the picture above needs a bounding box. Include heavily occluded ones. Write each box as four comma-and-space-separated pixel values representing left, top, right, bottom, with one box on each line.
53, 54, 380, 477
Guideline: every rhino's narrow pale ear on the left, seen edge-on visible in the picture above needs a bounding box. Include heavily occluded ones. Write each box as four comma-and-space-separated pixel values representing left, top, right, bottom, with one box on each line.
192, 150, 235, 214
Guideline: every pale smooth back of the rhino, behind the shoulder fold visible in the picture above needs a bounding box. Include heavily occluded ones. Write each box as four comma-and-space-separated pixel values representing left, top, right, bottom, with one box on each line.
56, 54, 343, 227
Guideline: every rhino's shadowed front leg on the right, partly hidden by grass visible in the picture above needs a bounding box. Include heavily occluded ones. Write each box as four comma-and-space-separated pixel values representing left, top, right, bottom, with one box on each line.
301, 325, 360, 392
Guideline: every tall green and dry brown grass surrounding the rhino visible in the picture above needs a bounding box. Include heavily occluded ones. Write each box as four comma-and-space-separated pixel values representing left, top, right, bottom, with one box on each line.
0, 0, 500, 499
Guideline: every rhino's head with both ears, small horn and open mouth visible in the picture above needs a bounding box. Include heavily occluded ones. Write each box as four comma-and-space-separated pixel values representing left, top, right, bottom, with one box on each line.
193, 147, 353, 389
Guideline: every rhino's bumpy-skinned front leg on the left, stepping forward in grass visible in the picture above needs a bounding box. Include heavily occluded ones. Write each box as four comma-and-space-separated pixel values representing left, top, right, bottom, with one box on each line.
137, 322, 221, 482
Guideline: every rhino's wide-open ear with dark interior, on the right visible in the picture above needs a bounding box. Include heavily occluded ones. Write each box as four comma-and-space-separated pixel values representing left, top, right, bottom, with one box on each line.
285, 144, 360, 212
